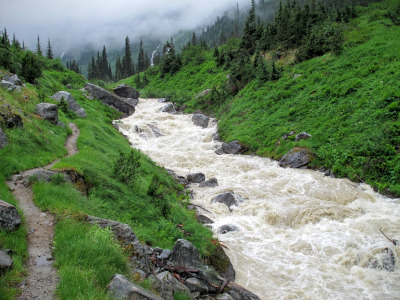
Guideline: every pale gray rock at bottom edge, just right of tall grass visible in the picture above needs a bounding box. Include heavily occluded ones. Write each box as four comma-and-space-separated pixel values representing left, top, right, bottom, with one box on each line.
107, 274, 163, 300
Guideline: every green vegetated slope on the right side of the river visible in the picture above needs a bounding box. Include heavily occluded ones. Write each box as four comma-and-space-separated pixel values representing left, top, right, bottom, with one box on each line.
134, 0, 400, 196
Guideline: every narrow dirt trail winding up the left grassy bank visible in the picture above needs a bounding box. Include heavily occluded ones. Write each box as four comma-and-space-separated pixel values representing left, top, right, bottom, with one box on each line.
8, 123, 79, 300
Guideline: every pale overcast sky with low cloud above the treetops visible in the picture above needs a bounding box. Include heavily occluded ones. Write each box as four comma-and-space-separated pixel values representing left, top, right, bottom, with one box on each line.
0, 0, 251, 51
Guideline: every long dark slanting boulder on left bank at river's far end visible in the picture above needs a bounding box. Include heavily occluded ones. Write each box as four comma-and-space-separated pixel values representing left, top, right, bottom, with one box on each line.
85, 83, 135, 115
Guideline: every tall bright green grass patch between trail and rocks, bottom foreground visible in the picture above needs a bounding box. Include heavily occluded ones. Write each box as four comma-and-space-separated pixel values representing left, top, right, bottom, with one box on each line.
54, 219, 128, 299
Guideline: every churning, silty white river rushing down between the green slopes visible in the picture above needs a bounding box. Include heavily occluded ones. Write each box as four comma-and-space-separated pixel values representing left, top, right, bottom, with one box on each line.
116, 99, 400, 299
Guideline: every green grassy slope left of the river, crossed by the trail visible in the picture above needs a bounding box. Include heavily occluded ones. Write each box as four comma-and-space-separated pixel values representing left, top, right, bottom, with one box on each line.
0, 63, 215, 299
